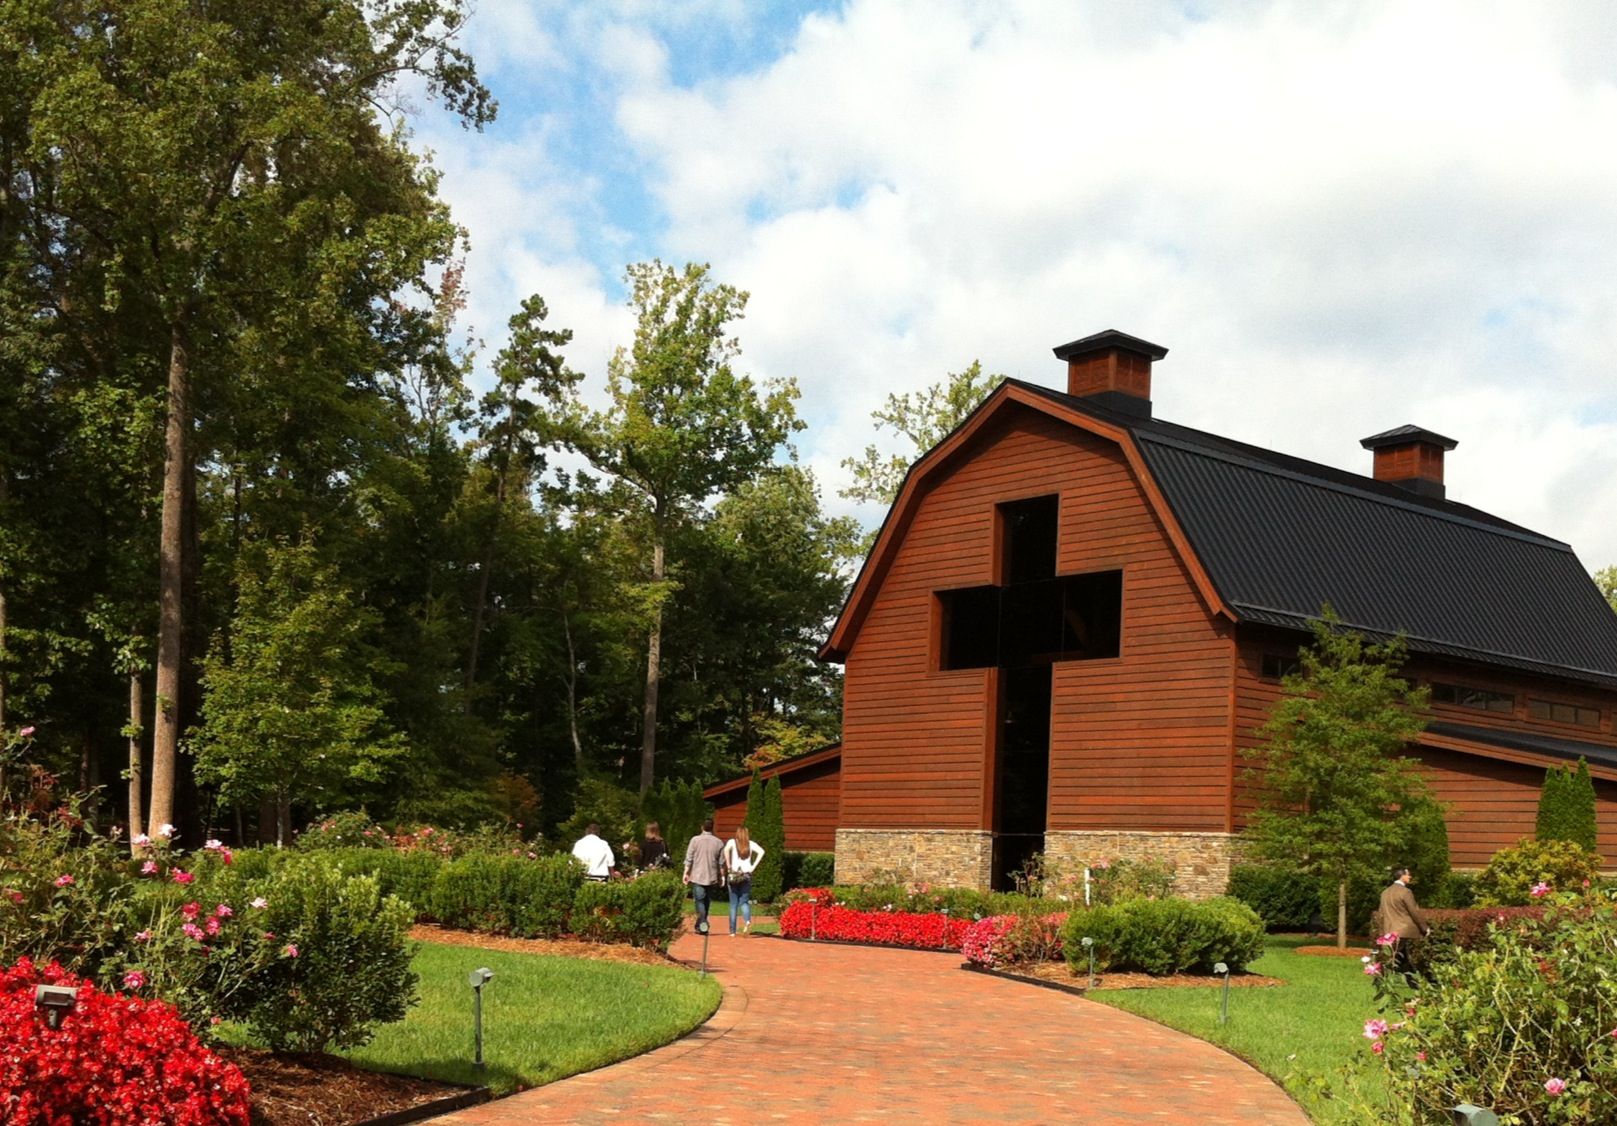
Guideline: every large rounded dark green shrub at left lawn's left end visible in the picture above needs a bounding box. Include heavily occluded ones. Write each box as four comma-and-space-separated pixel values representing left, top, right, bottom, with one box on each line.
244, 857, 417, 1052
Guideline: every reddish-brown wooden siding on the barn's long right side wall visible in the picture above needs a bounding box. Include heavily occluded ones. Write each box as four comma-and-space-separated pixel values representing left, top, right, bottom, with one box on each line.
1235, 637, 1617, 867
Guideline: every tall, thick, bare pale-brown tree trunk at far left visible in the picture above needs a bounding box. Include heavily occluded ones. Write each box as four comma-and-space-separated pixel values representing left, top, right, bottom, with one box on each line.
146, 322, 191, 832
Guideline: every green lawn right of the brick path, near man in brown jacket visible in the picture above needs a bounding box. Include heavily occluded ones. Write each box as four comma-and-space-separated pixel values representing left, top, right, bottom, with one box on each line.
1090, 935, 1376, 1123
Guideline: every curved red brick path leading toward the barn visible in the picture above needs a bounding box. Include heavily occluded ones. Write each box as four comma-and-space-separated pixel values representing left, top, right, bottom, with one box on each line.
433, 914, 1308, 1126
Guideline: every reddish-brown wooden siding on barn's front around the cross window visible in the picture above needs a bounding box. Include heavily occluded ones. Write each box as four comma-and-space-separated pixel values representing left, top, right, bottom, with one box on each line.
842, 413, 1229, 830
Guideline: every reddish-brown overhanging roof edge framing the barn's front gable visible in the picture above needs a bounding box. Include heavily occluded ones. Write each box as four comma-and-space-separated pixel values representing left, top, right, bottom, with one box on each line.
818, 380, 1235, 662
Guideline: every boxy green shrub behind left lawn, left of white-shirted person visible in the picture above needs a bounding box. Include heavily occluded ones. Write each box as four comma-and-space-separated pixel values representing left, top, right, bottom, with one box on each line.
427, 856, 584, 938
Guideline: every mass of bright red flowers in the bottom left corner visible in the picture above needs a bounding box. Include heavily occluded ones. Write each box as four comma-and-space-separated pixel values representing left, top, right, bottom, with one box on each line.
0, 958, 251, 1126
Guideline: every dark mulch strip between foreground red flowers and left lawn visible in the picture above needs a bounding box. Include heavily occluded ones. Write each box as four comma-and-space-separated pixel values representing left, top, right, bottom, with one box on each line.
218, 1048, 478, 1126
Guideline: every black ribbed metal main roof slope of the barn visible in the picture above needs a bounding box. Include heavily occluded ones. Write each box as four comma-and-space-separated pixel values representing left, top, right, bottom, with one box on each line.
1019, 383, 1617, 688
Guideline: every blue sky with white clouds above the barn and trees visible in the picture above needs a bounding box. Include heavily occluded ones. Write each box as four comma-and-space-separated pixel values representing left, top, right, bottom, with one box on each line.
416, 0, 1617, 569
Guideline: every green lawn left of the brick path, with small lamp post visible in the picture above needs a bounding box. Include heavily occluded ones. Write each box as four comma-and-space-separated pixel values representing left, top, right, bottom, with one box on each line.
346, 943, 720, 1092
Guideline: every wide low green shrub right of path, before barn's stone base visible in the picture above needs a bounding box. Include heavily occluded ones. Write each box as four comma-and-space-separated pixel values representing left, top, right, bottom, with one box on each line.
1061, 896, 1263, 976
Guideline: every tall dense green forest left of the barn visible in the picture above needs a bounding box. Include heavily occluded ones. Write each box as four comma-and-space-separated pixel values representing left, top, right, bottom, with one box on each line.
0, 0, 859, 845
